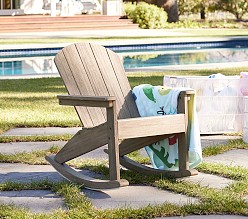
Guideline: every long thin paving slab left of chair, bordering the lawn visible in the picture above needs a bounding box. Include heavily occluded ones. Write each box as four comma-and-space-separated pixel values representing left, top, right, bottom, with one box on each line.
1, 127, 82, 136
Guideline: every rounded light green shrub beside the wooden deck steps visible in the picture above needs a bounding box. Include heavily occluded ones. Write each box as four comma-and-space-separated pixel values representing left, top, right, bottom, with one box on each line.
125, 2, 167, 29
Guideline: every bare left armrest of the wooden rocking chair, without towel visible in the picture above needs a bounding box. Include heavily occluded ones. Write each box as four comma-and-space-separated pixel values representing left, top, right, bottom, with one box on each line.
57, 95, 116, 108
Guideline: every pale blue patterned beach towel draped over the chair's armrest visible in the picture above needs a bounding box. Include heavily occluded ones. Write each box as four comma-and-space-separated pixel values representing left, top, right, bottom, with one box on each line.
133, 84, 202, 170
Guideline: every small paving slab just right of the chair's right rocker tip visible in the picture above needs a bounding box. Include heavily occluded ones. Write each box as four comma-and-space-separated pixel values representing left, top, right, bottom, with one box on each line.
178, 173, 234, 189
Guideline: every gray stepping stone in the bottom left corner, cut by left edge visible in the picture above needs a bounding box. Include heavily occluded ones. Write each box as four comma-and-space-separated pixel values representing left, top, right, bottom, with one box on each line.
0, 190, 66, 213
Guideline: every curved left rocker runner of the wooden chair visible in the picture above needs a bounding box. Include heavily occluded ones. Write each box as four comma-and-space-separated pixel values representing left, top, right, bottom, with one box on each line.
46, 155, 129, 189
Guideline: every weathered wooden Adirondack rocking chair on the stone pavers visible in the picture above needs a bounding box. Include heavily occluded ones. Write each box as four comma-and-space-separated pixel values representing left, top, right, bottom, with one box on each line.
46, 43, 197, 189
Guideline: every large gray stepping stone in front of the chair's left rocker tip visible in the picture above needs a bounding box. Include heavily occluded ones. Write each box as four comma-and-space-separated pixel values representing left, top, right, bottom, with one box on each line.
82, 185, 197, 209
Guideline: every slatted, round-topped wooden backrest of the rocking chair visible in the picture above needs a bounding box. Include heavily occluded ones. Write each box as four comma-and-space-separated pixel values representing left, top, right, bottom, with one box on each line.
54, 43, 139, 127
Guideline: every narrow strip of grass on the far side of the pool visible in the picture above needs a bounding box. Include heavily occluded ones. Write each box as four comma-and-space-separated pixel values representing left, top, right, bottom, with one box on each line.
0, 27, 248, 45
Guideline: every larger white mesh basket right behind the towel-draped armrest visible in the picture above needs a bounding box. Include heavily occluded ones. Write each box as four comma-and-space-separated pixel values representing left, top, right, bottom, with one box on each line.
164, 76, 248, 134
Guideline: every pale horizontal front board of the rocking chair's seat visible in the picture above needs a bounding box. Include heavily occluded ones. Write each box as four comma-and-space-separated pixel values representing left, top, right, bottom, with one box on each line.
118, 114, 185, 139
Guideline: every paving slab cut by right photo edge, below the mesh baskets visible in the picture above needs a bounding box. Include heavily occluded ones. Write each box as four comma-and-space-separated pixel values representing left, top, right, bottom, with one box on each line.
204, 149, 248, 168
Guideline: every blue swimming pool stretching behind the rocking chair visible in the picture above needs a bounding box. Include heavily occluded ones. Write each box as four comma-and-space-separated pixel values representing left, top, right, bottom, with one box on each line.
0, 39, 248, 76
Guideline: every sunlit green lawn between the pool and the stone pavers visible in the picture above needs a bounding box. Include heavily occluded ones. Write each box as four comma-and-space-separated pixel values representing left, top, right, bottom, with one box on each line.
0, 68, 247, 133
